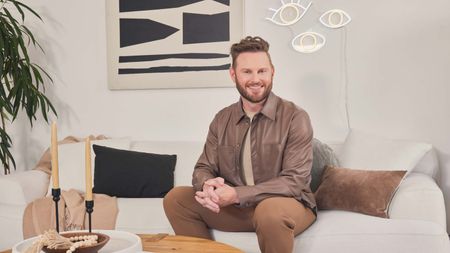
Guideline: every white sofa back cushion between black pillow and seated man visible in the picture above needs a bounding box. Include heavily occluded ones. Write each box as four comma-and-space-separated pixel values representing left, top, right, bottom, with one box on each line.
131, 141, 204, 186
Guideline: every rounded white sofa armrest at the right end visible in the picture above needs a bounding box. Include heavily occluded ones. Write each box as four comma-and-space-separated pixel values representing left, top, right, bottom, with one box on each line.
389, 173, 447, 229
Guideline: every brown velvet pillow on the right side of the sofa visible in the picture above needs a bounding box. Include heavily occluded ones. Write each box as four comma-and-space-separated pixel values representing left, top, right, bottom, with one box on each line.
315, 166, 406, 218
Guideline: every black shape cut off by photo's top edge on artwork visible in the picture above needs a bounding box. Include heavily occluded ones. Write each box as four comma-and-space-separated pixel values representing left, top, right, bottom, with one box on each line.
119, 0, 204, 12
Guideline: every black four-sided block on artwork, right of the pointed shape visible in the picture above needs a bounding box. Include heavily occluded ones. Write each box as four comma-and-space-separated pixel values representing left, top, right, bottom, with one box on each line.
183, 12, 230, 44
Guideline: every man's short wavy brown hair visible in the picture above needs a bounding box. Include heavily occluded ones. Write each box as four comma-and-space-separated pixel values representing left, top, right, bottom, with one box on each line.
230, 36, 272, 68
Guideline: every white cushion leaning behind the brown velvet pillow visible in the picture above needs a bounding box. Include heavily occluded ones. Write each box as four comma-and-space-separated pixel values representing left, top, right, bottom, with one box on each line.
339, 129, 432, 173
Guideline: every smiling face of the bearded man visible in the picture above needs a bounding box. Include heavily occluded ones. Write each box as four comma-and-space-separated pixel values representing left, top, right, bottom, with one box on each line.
230, 52, 274, 103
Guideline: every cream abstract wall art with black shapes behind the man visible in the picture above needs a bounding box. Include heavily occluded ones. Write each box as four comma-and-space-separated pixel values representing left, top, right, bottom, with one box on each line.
106, 0, 244, 89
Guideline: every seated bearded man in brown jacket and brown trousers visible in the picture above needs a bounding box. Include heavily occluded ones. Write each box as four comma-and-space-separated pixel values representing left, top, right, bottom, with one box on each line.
164, 36, 316, 253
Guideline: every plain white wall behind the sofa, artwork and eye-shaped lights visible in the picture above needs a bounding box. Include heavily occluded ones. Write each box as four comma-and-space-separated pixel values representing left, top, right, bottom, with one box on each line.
6, 0, 450, 233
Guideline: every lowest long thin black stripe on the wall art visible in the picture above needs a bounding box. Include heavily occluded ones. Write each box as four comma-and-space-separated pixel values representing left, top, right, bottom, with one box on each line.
118, 64, 231, 75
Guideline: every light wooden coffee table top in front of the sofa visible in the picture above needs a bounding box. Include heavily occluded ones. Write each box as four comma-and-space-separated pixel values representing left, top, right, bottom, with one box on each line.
0, 234, 243, 253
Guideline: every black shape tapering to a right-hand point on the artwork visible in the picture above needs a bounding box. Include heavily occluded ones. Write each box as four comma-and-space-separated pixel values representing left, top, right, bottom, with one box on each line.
120, 18, 179, 47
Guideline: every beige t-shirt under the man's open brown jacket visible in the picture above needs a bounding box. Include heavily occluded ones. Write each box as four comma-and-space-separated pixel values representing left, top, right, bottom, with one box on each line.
241, 111, 256, 185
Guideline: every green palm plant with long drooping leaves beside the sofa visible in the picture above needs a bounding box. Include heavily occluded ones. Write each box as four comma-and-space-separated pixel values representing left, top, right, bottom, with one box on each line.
0, 0, 56, 174
